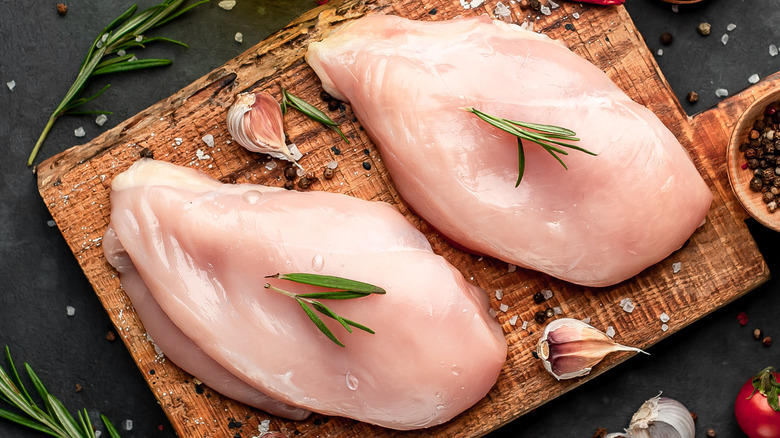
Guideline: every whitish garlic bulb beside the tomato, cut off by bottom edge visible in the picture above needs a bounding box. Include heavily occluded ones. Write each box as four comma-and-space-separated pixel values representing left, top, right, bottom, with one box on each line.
605, 394, 696, 438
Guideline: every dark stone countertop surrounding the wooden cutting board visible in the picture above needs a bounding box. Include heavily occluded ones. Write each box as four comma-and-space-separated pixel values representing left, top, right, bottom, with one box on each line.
0, 0, 780, 438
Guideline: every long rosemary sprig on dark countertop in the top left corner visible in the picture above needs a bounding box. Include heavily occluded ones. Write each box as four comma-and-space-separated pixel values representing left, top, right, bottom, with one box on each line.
27, 0, 209, 166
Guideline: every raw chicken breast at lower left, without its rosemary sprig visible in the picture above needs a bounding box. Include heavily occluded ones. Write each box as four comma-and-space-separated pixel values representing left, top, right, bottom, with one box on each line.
105, 160, 507, 429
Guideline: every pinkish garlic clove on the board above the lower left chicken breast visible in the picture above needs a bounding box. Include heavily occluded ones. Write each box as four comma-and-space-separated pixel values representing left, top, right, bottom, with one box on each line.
227, 92, 301, 164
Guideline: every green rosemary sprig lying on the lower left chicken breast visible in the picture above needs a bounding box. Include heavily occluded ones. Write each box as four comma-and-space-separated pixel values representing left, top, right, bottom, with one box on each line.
265, 273, 385, 347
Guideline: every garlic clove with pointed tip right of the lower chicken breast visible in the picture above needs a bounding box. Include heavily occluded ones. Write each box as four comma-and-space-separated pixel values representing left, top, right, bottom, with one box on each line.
536, 318, 648, 380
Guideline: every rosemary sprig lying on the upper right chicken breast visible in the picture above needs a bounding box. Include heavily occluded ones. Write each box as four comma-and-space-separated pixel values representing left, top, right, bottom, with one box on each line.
464, 107, 596, 187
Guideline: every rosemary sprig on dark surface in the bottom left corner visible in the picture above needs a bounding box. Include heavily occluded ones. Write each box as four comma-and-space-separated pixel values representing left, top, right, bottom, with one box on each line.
0, 346, 119, 438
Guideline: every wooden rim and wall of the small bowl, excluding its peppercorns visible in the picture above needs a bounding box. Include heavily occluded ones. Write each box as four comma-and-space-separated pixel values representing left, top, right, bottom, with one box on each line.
726, 88, 780, 231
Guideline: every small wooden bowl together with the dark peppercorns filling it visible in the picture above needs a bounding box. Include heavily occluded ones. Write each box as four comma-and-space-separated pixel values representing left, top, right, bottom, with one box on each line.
726, 89, 780, 231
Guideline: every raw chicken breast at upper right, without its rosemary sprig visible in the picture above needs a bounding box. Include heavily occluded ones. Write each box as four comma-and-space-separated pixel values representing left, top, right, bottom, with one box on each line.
306, 16, 712, 286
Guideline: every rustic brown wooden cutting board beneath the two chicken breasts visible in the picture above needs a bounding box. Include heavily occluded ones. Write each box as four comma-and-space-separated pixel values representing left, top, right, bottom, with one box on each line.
38, 0, 780, 438
